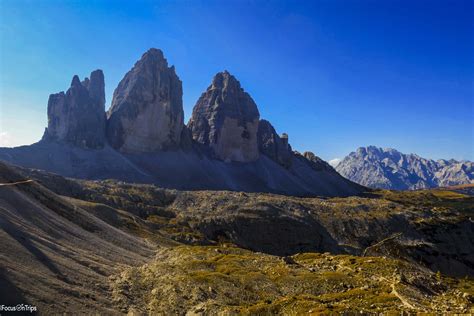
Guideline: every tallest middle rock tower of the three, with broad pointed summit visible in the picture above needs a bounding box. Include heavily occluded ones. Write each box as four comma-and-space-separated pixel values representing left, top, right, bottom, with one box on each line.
107, 48, 184, 153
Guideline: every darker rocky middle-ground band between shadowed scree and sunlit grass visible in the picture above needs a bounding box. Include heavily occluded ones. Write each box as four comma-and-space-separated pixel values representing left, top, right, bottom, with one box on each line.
19, 165, 474, 276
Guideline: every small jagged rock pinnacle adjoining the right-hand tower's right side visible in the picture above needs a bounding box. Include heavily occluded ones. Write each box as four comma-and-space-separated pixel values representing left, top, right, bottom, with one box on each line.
257, 120, 293, 168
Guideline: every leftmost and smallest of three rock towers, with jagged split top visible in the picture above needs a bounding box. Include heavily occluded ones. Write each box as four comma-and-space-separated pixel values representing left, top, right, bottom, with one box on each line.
43, 70, 105, 148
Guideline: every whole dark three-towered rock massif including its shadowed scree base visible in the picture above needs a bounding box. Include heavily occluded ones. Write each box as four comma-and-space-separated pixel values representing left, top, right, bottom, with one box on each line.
0, 48, 364, 196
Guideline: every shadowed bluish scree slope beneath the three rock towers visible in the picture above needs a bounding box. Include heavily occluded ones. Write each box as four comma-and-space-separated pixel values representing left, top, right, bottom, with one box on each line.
0, 142, 364, 196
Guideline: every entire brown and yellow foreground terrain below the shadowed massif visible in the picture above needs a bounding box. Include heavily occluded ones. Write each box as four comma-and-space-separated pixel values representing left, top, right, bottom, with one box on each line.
0, 163, 474, 315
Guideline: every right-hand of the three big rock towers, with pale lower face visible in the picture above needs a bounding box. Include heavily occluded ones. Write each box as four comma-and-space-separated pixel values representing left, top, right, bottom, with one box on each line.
188, 71, 260, 162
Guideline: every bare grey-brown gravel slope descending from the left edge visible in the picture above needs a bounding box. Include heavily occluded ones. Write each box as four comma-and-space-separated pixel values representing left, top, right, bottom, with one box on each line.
0, 164, 153, 315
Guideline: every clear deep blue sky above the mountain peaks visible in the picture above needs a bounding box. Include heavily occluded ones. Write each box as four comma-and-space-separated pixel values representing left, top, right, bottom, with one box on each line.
0, 0, 474, 160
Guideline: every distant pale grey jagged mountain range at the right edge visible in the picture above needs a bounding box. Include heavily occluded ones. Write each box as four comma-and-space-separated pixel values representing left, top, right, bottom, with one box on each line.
336, 146, 474, 190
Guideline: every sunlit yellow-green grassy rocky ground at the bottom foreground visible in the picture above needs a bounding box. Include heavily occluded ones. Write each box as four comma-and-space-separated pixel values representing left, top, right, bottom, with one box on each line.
112, 246, 474, 315
